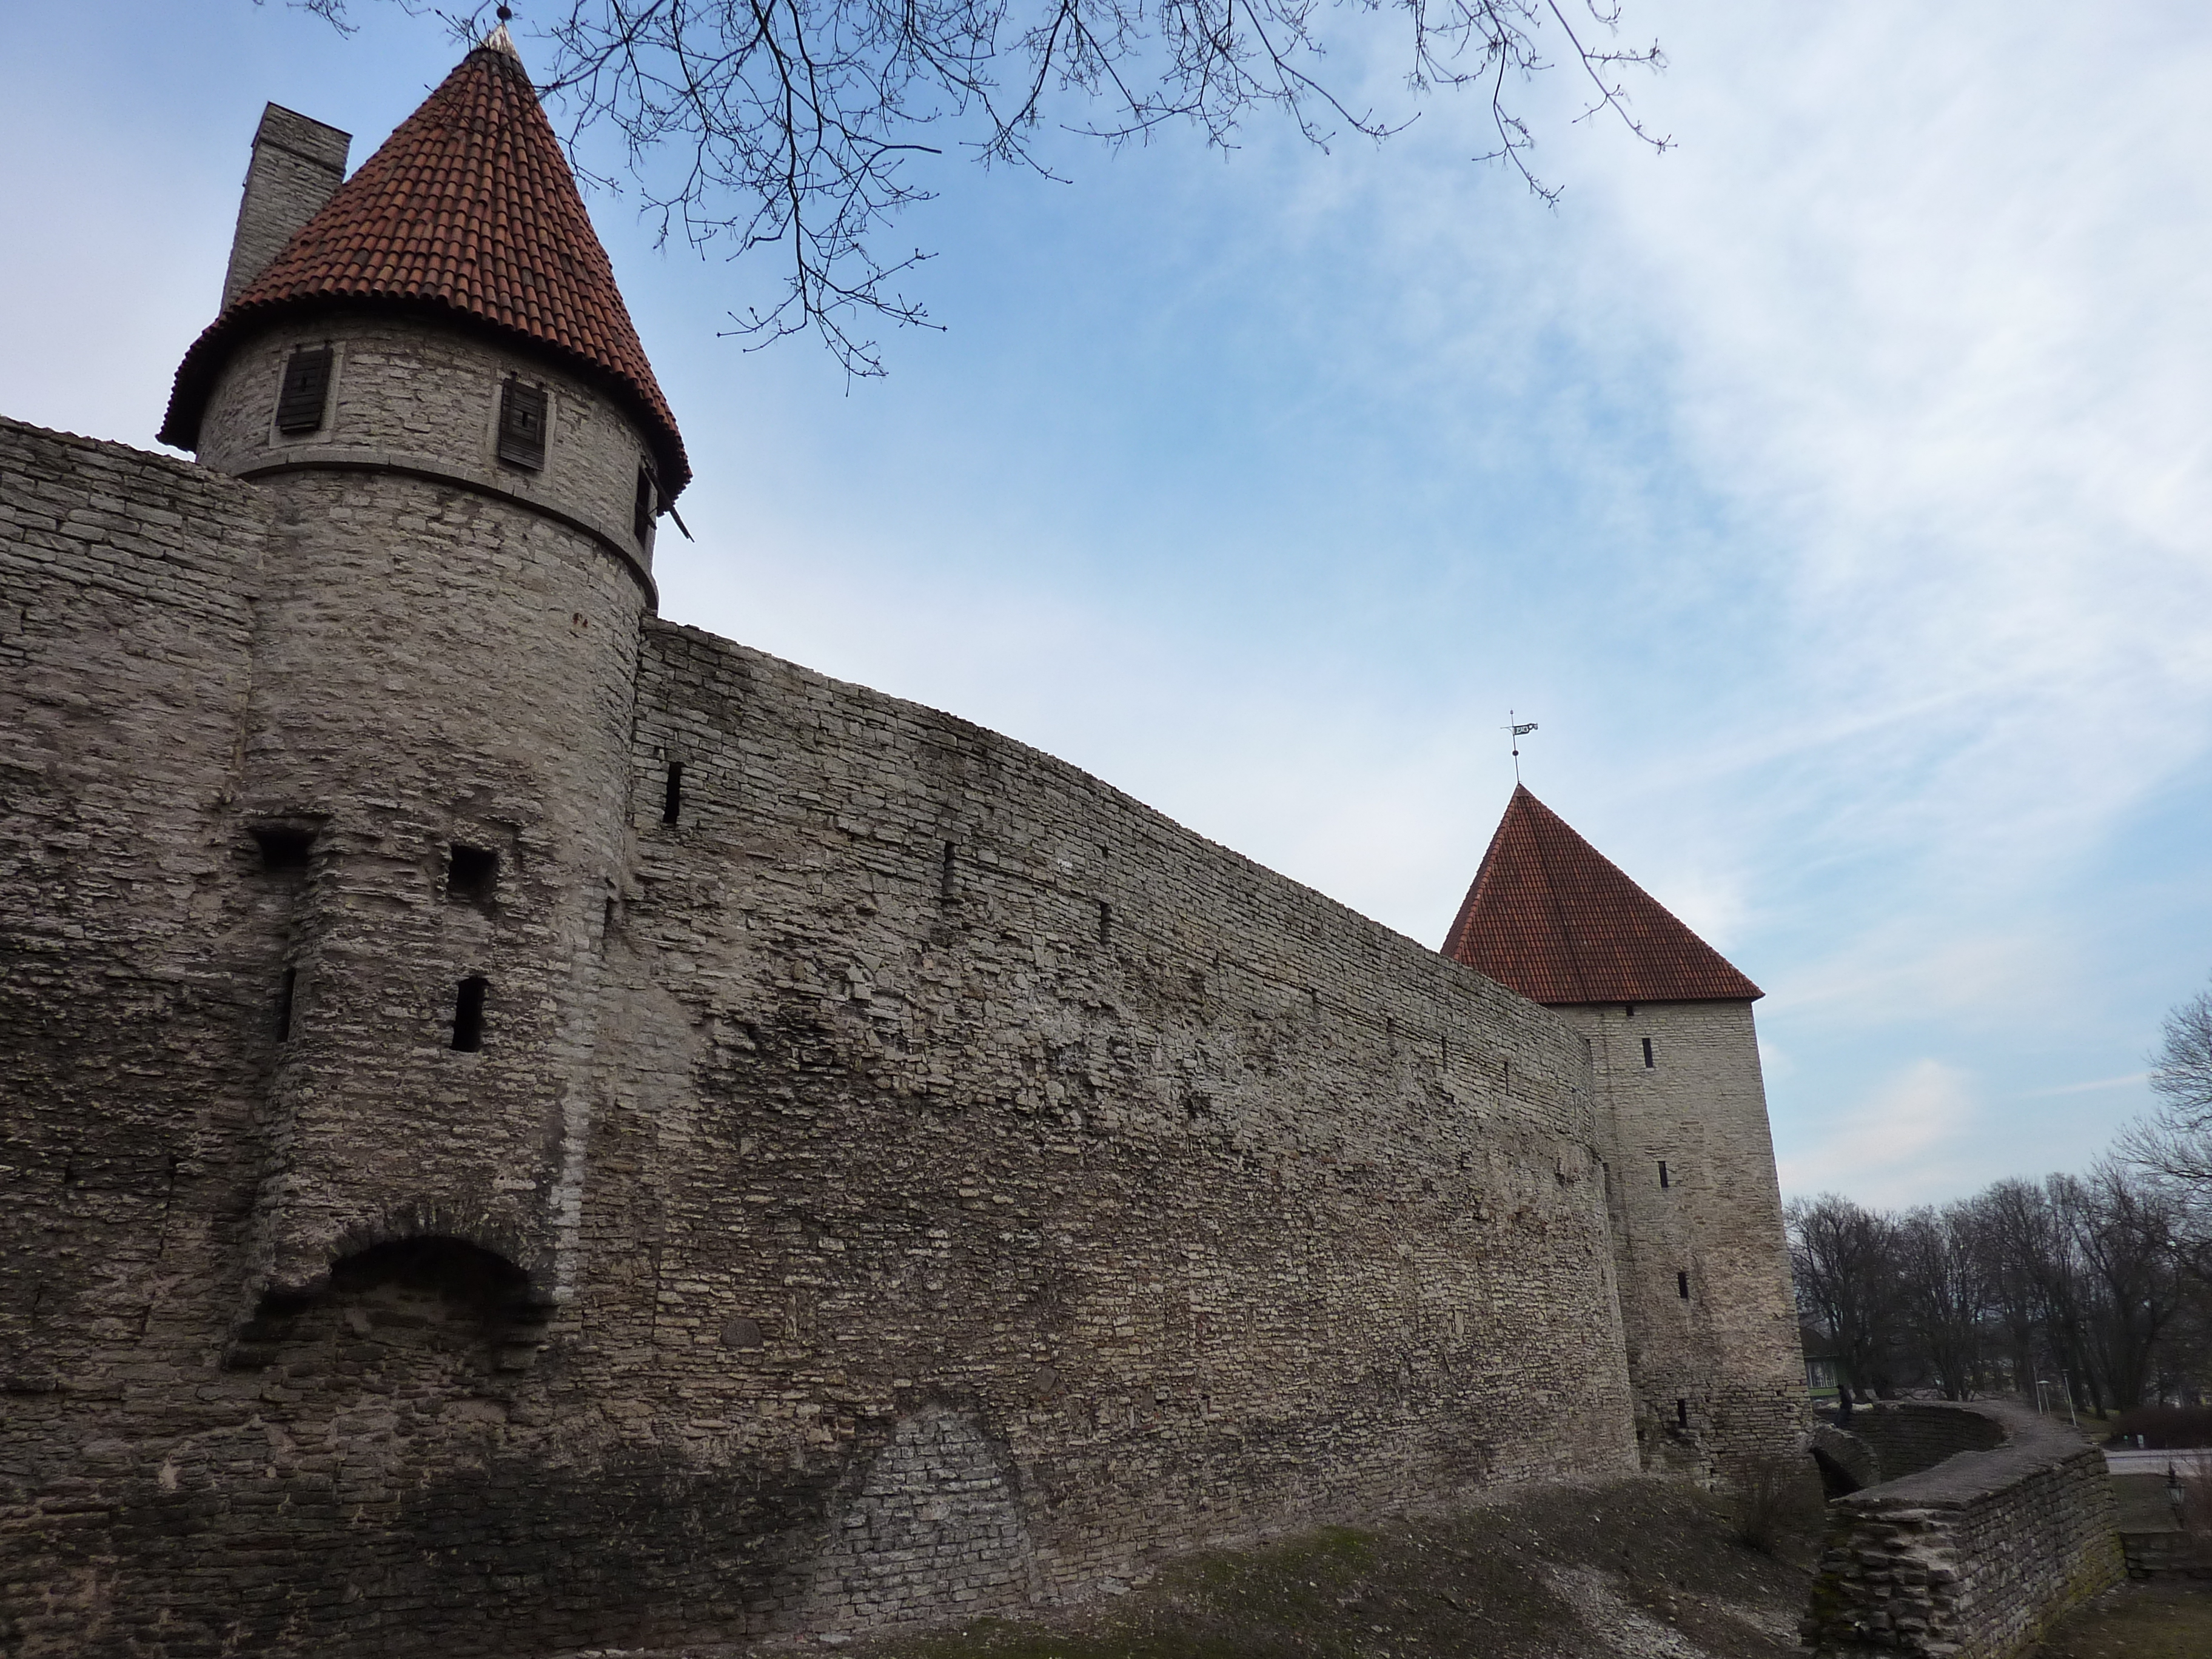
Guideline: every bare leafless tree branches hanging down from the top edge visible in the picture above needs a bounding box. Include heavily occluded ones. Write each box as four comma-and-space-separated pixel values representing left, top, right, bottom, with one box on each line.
272, 0, 1668, 374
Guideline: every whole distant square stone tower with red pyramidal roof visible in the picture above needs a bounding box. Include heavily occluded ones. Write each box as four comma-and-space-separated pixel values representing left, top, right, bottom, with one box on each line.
1444, 785, 1805, 1475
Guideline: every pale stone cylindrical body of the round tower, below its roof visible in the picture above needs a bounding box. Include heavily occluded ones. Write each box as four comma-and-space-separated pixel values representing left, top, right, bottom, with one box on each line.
201, 314, 648, 1309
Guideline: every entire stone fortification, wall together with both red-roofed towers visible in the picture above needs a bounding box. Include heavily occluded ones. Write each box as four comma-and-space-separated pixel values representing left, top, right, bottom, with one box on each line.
0, 31, 1805, 1659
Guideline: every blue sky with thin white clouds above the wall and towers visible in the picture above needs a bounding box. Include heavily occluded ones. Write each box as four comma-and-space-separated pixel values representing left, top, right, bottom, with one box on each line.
0, 0, 2212, 1204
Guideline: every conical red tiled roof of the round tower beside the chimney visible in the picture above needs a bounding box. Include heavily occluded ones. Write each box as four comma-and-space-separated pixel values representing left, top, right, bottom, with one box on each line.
161, 35, 690, 495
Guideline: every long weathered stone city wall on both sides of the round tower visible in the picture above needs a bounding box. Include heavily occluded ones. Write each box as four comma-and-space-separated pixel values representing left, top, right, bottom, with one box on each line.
0, 424, 1635, 1659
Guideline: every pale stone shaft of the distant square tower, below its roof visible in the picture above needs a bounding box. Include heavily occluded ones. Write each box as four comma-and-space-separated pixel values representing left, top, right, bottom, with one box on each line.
1557, 1002, 1807, 1471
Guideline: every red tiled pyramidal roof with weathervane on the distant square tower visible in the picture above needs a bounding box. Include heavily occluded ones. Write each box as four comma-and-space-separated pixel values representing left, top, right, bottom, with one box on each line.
1444, 785, 1765, 1007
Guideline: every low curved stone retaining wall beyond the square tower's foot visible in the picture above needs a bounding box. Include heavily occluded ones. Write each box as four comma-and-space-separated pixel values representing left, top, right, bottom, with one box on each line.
1805, 1400, 2126, 1659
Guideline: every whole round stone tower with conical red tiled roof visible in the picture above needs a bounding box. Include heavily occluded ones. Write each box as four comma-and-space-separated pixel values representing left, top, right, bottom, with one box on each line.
161, 28, 688, 1307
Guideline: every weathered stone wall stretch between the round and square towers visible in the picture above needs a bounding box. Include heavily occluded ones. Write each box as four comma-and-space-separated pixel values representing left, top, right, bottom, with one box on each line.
581, 624, 1632, 1624
